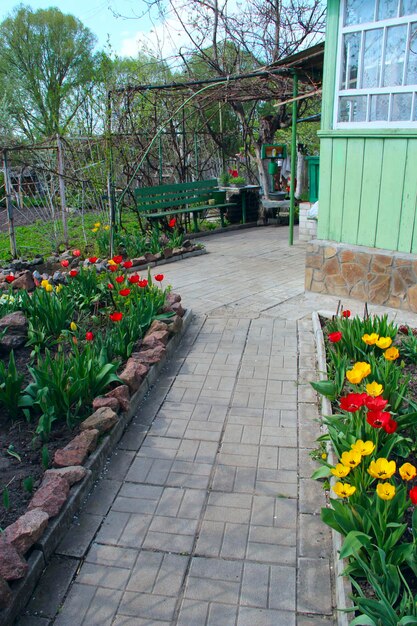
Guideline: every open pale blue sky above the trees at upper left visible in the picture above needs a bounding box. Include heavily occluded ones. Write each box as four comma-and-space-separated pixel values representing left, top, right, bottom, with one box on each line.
0, 0, 166, 56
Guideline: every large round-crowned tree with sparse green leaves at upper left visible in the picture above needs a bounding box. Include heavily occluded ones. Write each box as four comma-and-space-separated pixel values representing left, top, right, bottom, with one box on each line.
0, 5, 95, 140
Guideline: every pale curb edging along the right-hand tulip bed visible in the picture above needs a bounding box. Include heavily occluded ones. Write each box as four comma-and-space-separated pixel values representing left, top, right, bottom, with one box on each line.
311, 311, 353, 626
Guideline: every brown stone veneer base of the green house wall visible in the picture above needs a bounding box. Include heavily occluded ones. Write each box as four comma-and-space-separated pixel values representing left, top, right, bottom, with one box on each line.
305, 239, 417, 312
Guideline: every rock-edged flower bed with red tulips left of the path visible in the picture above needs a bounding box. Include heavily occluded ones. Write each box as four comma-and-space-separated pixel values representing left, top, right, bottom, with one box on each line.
0, 250, 184, 623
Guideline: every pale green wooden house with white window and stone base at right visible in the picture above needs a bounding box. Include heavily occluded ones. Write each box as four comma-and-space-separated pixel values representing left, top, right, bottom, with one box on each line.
306, 0, 417, 311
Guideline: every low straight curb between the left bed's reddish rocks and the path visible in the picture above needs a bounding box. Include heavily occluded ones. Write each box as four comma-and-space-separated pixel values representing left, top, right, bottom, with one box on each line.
0, 308, 193, 626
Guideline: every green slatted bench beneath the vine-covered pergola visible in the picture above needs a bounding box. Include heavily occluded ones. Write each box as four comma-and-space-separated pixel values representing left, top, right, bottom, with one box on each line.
135, 178, 236, 231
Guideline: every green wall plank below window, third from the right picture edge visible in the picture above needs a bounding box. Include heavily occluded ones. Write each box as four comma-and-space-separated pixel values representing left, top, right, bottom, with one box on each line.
356, 138, 384, 247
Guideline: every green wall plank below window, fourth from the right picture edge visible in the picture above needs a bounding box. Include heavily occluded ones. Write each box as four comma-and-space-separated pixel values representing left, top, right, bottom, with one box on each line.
341, 138, 365, 242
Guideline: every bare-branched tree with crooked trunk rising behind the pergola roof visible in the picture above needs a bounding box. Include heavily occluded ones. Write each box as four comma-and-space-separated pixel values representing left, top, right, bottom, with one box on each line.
115, 0, 325, 191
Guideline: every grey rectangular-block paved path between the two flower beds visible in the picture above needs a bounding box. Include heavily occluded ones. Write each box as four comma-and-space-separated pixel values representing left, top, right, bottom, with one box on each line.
18, 227, 417, 626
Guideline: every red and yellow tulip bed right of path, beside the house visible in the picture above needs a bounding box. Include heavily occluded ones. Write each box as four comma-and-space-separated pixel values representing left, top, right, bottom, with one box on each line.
312, 311, 417, 626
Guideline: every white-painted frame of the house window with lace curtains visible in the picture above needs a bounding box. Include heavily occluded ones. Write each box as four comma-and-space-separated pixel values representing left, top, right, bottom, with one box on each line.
333, 0, 417, 129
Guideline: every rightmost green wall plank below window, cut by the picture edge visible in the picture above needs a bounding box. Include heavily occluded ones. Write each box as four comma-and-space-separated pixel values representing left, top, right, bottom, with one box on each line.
397, 141, 417, 252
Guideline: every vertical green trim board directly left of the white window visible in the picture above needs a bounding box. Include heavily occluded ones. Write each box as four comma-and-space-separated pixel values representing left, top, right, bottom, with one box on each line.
321, 0, 340, 129
